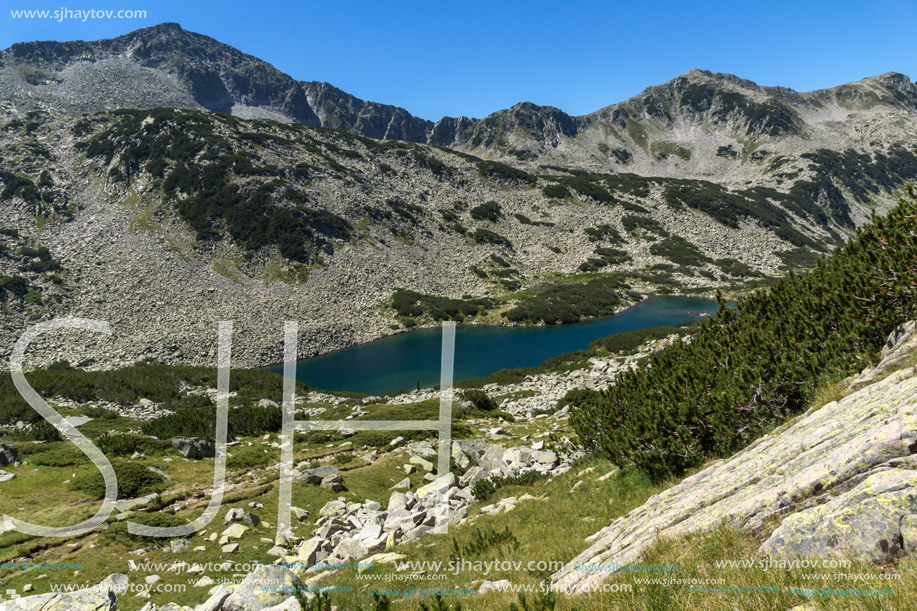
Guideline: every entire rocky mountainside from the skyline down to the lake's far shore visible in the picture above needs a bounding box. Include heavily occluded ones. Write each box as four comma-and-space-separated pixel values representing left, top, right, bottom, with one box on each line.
0, 24, 917, 366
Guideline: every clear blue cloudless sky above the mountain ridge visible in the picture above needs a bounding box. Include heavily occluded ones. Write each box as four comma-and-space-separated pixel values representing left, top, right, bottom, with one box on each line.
0, 0, 917, 120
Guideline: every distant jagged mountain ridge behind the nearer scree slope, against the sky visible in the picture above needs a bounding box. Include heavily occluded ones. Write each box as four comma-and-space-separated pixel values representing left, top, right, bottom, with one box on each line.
0, 23, 917, 177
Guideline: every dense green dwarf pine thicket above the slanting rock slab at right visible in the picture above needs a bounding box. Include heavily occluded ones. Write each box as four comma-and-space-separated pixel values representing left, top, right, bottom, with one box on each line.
570, 187, 917, 478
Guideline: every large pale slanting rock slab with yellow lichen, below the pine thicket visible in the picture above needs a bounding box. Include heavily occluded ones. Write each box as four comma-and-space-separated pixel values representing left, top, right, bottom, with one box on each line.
553, 323, 917, 591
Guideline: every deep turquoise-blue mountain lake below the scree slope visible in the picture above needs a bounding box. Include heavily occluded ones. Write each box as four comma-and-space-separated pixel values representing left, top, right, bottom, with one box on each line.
269, 297, 717, 395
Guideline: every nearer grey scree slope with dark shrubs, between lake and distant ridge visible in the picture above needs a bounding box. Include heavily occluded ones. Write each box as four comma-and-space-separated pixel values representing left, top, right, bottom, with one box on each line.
0, 111, 788, 366
